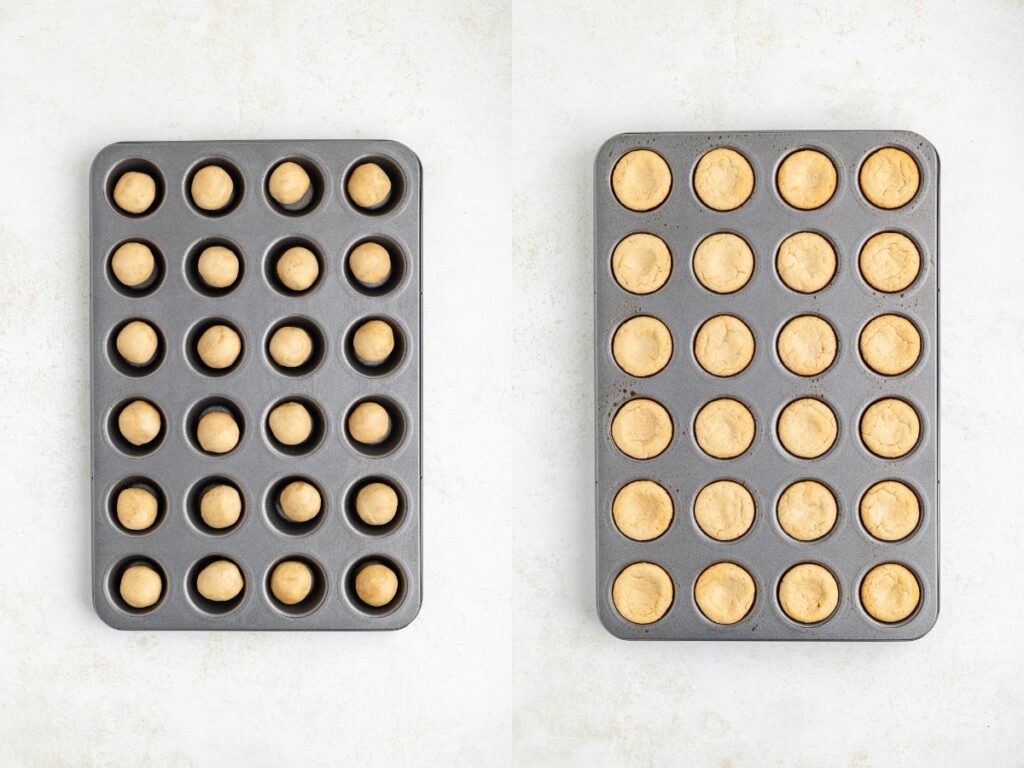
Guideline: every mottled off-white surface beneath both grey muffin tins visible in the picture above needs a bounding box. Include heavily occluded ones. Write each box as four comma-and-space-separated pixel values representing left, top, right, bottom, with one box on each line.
0, 0, 1024, 768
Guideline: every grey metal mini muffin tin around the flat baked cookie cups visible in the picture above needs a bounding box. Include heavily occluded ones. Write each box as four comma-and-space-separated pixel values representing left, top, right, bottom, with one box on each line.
594, 131, 939, 640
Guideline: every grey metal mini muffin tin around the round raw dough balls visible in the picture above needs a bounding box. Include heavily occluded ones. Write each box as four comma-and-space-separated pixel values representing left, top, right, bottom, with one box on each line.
90, 140, 421, 630
